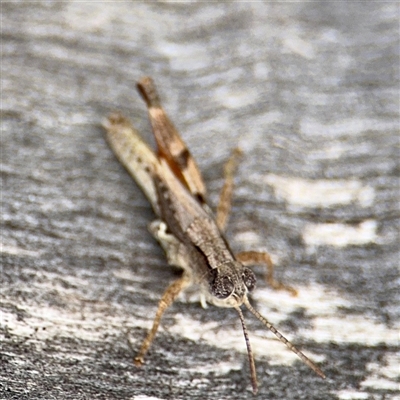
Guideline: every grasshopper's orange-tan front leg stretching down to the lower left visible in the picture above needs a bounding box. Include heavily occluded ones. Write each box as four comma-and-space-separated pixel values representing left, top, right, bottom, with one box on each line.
134, 274, 190, 366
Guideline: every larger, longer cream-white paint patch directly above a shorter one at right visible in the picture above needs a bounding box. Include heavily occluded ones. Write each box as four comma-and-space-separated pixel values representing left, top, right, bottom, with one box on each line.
264, 174, 375, 207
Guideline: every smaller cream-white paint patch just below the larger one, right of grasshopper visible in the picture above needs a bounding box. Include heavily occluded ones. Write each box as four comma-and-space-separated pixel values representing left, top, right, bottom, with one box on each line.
302, 220, 378, 247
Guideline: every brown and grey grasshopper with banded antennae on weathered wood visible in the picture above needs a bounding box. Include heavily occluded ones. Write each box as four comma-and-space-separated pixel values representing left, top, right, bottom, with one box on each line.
103, 77, 325, 394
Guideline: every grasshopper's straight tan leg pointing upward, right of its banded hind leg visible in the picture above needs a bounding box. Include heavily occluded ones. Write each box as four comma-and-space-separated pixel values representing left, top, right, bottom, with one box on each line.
216, 148, 242, 232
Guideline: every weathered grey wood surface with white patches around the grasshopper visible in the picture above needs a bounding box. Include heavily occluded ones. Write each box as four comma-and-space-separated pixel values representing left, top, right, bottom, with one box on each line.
0, 2, 400, 400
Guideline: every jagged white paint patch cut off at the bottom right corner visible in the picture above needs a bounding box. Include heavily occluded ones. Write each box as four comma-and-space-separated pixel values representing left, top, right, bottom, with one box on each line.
361, 354, 400, 391
